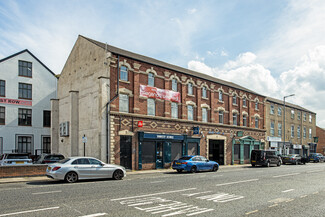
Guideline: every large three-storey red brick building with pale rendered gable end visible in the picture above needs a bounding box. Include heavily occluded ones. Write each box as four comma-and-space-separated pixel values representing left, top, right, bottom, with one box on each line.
52, 36, 265, 169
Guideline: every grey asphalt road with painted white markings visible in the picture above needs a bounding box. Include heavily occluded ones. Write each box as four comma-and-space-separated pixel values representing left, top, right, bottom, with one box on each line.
0, 163, 325, 217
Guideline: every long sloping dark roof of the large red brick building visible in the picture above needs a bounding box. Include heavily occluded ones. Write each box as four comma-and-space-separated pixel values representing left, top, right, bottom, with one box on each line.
79, 35, 264, 97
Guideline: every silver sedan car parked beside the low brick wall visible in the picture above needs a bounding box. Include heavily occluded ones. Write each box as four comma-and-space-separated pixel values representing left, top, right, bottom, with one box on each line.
46, 157, 126, 183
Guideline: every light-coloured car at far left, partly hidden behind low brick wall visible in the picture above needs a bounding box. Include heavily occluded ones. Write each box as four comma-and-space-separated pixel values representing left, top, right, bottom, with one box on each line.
0, 153, 32, 166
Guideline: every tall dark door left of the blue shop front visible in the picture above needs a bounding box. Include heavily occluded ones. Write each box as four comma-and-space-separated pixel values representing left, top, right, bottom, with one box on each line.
120, 136, 132, 169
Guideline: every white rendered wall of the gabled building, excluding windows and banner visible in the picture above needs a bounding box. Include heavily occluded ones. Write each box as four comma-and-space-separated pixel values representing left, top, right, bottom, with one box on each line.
0, 51, 57, 152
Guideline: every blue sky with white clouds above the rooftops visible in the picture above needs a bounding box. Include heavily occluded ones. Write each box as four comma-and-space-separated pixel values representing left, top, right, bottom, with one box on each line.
0, 0, 325, 128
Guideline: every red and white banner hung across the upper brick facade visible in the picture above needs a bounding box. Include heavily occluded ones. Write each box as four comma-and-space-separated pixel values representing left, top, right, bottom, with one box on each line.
140, 84, 181, 102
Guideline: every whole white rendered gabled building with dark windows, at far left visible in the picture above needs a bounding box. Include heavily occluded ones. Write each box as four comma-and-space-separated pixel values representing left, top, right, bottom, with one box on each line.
0, 49, 57, 154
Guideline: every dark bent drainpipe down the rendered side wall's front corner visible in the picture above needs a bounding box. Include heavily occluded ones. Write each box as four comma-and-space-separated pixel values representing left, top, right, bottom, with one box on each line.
106, 55, 120, 163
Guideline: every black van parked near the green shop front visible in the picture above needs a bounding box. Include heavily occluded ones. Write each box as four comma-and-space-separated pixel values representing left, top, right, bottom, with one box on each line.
251, 150, 282, 167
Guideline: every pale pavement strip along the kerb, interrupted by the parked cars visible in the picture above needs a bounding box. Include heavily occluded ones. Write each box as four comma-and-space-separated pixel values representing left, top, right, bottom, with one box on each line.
0, 164, 250, 184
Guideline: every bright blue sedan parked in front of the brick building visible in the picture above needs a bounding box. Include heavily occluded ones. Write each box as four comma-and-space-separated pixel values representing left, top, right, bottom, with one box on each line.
172, 155, 219, 173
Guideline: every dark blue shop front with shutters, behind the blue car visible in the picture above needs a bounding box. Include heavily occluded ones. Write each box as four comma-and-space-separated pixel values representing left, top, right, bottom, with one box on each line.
138, 132, 200, 170
